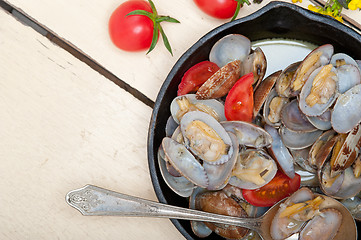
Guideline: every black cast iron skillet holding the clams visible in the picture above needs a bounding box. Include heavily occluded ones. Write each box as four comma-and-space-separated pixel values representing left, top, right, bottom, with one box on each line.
148, 2, 361, 239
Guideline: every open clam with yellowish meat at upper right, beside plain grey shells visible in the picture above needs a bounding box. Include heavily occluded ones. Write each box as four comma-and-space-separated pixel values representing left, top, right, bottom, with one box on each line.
299, 64, 338, 116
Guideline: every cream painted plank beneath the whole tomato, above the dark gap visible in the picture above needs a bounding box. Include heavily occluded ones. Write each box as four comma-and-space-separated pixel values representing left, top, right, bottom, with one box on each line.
6, 0, 344, 100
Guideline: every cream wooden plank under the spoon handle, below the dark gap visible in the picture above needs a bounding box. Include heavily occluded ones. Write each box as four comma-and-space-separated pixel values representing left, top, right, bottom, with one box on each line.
0, 9, 183, 240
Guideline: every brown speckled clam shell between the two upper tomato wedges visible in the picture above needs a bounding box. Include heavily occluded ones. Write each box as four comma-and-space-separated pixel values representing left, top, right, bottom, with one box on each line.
196, 60, 241, 99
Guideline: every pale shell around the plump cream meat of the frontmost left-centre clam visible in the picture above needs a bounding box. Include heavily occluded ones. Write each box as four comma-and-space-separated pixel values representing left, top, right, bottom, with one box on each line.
180, 111, 233, 164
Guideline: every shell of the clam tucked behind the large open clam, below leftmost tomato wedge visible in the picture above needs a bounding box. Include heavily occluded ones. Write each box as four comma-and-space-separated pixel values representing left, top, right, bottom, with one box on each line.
170, 94, 226, 124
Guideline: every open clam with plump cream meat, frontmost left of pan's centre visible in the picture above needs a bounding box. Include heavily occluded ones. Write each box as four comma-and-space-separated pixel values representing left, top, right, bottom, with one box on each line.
180, 111, 233, 164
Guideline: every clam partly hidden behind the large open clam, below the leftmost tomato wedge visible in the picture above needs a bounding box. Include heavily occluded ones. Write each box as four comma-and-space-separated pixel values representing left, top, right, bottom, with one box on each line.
170, 94, 226, 124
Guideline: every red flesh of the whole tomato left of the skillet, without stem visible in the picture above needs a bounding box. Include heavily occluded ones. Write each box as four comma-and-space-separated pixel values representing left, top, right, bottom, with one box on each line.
109, 0, 154, 51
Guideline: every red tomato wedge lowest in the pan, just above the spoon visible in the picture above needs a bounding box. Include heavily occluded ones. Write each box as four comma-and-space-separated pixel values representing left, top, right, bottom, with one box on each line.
242, 170, 301, 207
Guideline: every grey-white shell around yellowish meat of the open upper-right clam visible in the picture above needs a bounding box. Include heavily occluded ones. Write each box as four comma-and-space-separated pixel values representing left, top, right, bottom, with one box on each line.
299, 67, 338, 116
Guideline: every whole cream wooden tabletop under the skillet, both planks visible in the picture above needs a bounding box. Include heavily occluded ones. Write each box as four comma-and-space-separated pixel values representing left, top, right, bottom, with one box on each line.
0, 0, 361, 240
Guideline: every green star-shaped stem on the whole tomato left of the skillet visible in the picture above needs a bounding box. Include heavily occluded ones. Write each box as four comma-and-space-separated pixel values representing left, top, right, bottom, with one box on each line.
126, 0, 179, 56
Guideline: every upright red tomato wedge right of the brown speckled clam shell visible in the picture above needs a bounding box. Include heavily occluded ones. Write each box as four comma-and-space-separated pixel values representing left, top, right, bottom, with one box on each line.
224, 73, 254, 122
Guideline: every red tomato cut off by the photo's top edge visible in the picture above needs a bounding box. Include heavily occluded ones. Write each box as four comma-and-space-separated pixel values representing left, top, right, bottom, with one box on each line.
194, 0, 237, 19
